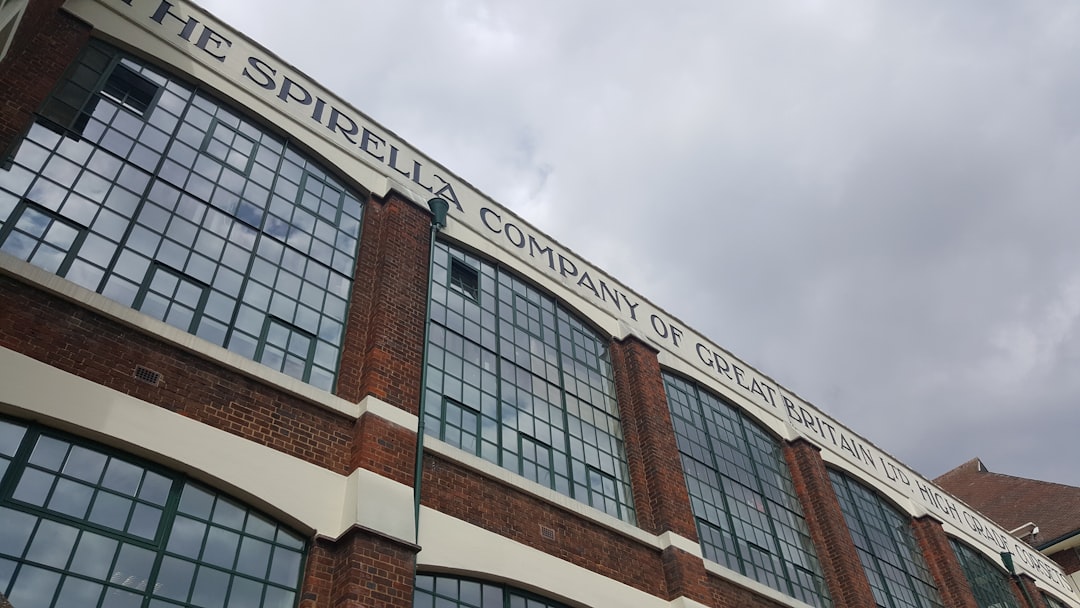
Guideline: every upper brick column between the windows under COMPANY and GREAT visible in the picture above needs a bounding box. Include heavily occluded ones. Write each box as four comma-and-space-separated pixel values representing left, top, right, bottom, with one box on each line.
611, 337, 698, 541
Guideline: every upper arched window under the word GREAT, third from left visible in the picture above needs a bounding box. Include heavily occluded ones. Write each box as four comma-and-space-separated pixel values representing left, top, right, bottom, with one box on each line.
664, 374, 832, 606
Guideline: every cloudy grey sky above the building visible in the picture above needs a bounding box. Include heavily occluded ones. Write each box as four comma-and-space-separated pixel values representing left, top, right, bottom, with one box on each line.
199, 0, 1080, 486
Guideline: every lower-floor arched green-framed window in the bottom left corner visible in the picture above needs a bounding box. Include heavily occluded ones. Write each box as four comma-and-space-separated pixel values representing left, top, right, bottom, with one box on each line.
0, 418, 305, 608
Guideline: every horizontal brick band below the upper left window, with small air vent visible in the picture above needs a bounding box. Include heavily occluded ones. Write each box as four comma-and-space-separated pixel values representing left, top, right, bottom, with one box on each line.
0, 276, 353, 474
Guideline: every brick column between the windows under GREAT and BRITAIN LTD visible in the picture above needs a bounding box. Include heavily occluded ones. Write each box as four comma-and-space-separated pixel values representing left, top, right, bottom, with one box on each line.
784, 438, 876, 608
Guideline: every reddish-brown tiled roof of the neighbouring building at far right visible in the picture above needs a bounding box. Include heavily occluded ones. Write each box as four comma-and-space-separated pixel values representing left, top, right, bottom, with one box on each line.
934, 458, 1080, 548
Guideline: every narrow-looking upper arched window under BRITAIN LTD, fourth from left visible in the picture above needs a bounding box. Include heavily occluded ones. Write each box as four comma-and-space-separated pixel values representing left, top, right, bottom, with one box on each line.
828, 470, 942, 608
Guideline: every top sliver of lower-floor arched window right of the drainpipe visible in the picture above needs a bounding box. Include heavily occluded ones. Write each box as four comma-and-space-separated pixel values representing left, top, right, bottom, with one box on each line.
413, 575, 566, 608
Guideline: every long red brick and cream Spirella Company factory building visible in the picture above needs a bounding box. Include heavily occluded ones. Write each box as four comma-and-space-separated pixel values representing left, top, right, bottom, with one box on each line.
0, 0, 1080, 608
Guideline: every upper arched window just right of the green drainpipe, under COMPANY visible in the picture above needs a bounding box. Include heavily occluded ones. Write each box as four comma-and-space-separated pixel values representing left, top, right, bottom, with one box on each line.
424, 243, 634, 523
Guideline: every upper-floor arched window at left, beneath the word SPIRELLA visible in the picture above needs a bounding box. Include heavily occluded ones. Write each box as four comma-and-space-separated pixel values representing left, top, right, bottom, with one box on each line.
0, 41, 362, 390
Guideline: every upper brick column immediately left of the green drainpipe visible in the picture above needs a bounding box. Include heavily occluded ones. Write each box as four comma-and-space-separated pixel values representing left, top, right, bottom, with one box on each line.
338, 192, 431, 414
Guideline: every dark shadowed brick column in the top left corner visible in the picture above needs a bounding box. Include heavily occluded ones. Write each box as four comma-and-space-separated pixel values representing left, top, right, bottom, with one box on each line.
0, 0, 91, 164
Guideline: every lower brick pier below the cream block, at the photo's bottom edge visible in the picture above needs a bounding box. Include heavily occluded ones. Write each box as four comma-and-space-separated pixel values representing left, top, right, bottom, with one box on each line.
300, 528, 416, 608
